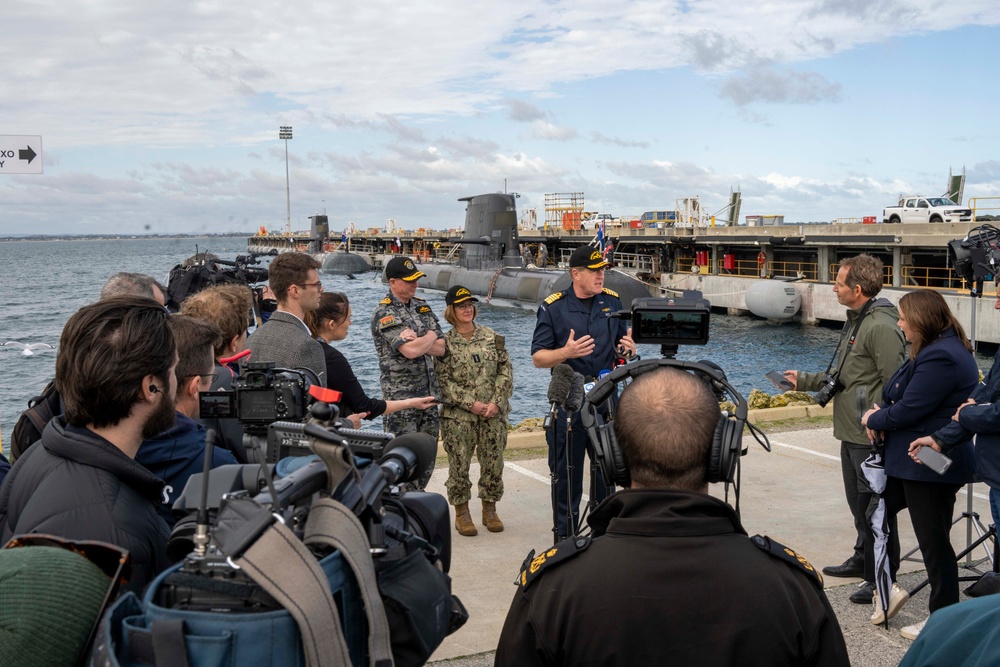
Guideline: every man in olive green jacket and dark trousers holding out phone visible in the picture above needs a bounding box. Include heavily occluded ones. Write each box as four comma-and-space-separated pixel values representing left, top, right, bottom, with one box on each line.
784, 254, 906, 604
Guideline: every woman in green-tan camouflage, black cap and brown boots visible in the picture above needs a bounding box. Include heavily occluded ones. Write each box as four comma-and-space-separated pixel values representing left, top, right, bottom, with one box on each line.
434, 285, 514, 537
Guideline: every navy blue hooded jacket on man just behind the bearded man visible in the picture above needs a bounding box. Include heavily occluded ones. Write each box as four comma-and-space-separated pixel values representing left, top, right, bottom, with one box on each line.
135, 412, 237, 527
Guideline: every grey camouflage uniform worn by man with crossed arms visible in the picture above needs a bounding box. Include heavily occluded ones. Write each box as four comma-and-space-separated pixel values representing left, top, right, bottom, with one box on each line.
371, 292, 444, 438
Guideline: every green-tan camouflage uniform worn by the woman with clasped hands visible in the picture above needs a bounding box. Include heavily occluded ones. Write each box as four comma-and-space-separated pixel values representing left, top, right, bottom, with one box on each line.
435, 325, 514, 505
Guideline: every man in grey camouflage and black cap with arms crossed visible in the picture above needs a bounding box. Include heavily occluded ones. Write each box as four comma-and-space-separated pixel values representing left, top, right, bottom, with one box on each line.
371, 257, 445, 438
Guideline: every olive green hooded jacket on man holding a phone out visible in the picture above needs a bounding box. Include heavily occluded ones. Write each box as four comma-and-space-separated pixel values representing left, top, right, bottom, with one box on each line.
797, 298, 906, 447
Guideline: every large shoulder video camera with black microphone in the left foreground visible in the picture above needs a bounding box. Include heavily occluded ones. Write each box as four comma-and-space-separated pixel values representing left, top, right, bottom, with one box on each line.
162, 388, 468, 664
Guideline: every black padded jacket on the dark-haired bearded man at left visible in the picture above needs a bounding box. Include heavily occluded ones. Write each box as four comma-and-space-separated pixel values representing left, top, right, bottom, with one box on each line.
0, 416, 170, 593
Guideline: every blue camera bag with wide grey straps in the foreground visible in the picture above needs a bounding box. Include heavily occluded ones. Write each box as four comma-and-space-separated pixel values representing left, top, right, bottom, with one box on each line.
92, 499, 393, 667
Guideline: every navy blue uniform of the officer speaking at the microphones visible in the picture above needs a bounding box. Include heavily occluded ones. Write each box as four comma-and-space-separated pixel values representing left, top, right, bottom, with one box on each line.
531, 288, 628, 539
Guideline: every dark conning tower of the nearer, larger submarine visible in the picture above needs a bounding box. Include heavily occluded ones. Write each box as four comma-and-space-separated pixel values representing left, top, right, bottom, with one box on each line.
458, 192, 522, 270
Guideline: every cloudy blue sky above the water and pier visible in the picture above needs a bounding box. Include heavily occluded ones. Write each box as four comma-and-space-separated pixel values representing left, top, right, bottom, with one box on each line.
0, 0, 1000, 236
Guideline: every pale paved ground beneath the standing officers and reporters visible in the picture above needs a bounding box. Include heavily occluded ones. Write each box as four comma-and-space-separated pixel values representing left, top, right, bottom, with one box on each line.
429, 427, 990, 667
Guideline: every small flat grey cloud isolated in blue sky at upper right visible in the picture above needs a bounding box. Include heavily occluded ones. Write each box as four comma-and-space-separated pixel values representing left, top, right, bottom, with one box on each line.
719, 65, 841, 107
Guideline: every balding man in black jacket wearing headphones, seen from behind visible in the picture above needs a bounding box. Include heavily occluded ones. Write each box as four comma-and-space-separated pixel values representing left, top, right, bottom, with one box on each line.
495, 368, 849, 667
